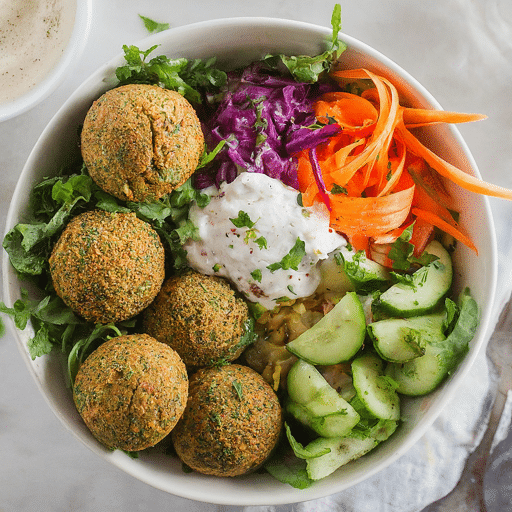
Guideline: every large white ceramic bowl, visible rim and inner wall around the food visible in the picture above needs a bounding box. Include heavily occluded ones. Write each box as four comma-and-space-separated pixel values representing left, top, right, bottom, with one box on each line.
3, 18, 497, 505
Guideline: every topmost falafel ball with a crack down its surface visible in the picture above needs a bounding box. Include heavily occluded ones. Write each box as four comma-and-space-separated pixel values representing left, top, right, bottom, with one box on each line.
81, 84, 204, 201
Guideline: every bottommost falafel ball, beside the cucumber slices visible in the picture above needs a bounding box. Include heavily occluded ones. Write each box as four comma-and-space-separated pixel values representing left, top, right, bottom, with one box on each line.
171, 364, 283, 476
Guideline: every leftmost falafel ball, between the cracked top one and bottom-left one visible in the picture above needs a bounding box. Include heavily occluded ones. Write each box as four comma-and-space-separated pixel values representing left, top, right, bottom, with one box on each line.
49, 210, 165, 324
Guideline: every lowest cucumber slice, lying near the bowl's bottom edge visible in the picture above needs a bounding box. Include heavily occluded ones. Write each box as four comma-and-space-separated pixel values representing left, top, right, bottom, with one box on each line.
306, 437, 379, 480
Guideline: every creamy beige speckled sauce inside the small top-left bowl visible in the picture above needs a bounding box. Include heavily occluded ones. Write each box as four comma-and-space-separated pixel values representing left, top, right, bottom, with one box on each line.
0, 0, 76, 103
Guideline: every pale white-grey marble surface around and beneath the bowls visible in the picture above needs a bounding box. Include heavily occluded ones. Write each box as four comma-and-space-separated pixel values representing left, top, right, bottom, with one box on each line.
0, 0, 512, 512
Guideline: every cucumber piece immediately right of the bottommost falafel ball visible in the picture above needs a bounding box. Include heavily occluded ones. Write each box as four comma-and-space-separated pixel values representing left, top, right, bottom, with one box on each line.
287, 359, 359, 437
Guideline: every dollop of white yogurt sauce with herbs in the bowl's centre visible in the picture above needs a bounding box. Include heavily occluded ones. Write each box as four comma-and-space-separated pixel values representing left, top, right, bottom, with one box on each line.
185, 172, 346, 309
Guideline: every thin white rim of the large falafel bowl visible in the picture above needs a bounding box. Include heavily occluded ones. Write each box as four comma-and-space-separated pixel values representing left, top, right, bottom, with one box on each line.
2, 17, 497, 506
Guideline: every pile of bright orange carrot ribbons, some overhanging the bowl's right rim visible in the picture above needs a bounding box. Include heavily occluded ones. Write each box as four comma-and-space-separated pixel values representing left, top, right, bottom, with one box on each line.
297, 68, 506, 254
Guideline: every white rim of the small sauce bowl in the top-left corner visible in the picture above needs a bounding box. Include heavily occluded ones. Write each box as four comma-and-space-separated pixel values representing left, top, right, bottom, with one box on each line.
0, 0, 92, 122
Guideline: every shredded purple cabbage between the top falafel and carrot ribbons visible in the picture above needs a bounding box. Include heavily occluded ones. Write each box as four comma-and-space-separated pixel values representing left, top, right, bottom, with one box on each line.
195, 61, 340, 189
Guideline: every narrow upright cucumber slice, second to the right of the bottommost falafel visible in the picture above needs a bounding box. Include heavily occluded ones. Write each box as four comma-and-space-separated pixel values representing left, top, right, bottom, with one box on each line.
352, 353, 400, 421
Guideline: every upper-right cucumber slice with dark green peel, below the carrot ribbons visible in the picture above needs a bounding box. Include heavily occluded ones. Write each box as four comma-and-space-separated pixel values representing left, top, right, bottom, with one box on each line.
375, 240, 453, 317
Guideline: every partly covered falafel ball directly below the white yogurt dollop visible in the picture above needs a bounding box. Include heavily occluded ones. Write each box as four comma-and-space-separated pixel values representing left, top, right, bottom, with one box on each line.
143, 271, 249, 367
